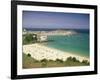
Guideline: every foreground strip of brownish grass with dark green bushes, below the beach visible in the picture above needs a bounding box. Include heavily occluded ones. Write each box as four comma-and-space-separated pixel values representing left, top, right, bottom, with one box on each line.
23, 53, 90, 68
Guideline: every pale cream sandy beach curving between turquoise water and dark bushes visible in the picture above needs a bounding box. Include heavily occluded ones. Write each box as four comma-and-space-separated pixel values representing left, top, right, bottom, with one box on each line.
23, 43, 90, 61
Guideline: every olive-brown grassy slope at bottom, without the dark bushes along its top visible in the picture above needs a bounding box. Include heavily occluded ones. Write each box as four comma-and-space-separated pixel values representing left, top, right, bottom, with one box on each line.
23, 54, 89, 69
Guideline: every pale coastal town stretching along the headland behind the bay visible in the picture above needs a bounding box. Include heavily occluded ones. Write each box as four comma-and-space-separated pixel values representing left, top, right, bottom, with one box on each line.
23, 29, 78, 41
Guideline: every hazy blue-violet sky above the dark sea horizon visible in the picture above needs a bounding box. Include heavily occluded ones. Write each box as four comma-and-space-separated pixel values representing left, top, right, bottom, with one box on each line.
22, 11, 89, 29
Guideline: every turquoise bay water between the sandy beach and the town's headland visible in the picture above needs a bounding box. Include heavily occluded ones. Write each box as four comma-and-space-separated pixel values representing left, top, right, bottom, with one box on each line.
44, 33, 89, 57
